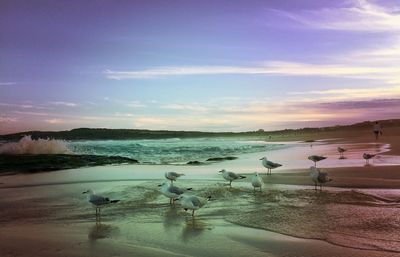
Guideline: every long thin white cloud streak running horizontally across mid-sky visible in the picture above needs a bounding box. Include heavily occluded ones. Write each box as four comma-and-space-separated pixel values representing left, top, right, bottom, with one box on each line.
106, 61, 400, 82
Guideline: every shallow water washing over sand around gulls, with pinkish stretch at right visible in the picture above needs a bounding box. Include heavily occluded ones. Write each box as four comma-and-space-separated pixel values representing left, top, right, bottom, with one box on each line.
0, 140, 400, 256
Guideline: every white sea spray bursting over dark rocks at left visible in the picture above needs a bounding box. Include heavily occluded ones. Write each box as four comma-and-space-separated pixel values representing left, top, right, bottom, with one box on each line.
0, 135, 72, 155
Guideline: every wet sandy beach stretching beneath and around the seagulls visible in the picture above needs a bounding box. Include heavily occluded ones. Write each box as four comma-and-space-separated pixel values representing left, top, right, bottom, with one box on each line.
0, 130, 400, 256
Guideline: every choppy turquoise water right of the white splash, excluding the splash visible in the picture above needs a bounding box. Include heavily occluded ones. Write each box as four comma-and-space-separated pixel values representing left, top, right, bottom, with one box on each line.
68, 138, 289, 164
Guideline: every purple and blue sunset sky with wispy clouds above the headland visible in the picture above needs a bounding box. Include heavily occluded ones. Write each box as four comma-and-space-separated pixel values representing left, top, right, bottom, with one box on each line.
0, 0, 400, 134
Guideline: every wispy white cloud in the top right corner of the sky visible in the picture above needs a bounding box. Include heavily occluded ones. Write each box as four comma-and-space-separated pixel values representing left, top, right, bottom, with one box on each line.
268, 0, 400, 33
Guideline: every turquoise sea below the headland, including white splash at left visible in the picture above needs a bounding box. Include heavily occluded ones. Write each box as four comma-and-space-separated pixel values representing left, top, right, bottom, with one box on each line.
0, 136, 290, 164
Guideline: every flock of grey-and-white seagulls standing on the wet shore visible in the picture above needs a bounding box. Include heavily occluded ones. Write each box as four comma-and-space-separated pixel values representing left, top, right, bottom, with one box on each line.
83, 147, 376, 217
